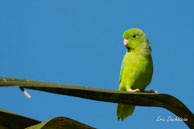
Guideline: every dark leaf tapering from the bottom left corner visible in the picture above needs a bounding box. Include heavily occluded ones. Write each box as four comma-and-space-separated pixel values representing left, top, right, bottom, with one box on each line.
0, 109, 40, 129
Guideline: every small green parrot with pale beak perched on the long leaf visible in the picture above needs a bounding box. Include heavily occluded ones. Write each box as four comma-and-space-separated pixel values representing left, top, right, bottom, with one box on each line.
117, 28, 157, 120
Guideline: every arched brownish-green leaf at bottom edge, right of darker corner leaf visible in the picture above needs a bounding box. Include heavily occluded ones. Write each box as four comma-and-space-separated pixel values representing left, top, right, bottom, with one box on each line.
27, 117, 94, 129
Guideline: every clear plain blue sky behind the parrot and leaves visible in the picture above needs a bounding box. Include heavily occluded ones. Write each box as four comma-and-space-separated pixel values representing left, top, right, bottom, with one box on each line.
0, 0, 194, 129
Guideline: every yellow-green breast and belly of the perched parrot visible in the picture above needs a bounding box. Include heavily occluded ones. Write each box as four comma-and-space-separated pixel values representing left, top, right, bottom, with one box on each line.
119, 52, 153, 91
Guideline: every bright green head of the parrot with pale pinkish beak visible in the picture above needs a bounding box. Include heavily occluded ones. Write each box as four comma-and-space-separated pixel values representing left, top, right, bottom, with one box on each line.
123, 28, 151, 51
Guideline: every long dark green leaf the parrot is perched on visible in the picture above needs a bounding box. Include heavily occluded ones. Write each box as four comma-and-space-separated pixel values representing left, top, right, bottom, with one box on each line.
0, 78, 194, 128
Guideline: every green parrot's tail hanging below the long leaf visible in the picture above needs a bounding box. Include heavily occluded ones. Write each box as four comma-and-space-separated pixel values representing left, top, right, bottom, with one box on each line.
117, 104, 135, 121
